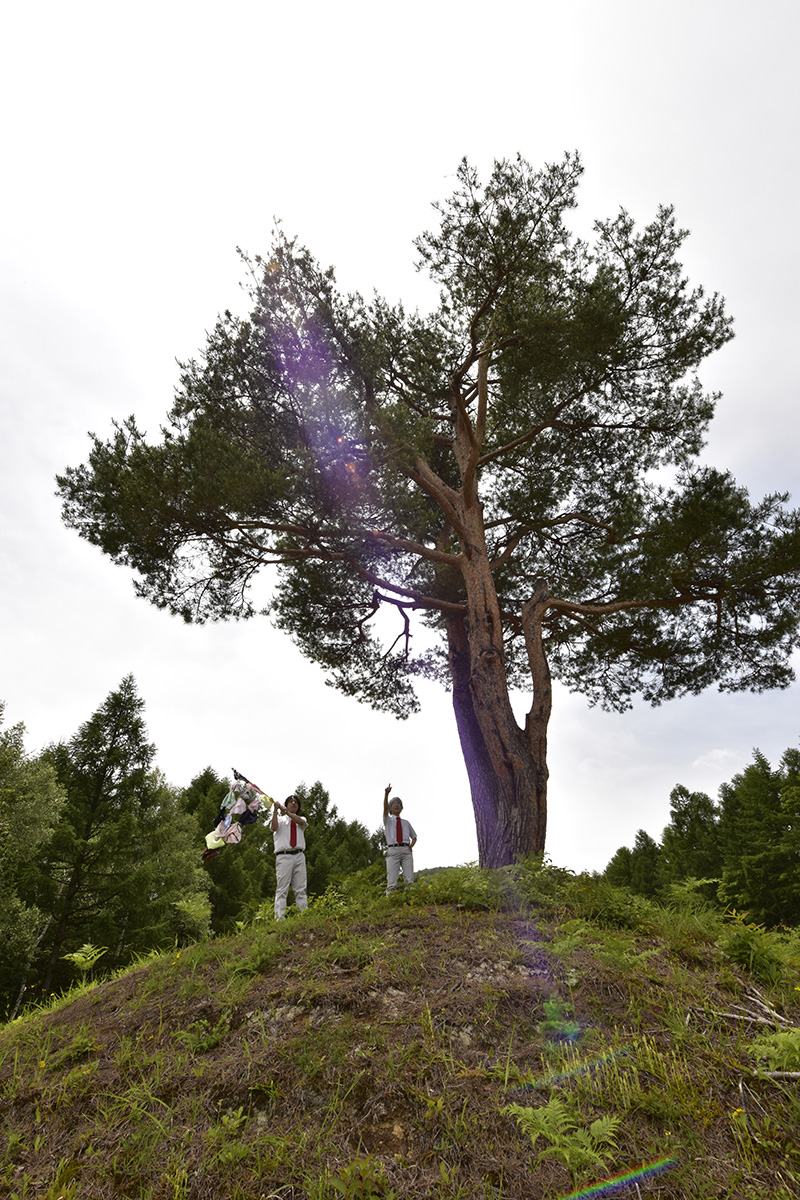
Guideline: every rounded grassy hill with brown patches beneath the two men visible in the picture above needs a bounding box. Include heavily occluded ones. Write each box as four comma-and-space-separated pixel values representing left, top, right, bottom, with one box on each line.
0, 863, 800, 1200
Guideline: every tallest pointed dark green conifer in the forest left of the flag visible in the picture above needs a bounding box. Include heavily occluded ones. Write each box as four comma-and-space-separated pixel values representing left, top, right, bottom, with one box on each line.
24, 676, 207, 991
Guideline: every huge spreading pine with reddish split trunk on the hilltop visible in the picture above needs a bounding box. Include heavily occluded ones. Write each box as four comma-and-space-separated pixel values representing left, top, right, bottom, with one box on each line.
59, 154, 800, 865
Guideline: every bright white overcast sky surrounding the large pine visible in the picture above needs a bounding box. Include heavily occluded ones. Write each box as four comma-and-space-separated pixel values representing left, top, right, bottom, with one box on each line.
0, 0, 800, 869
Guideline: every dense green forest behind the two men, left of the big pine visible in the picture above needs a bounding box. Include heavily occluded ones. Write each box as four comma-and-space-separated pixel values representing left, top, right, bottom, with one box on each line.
0, 676, 383, 1020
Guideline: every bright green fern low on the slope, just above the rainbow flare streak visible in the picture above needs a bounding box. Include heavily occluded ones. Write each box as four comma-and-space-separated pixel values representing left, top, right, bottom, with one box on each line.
501, 1096, 620, 1181
